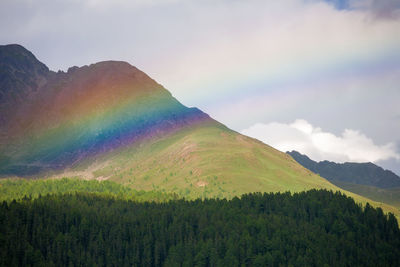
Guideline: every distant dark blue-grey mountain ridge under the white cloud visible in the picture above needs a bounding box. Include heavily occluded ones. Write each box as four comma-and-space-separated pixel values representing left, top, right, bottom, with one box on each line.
286, 151, 400, 188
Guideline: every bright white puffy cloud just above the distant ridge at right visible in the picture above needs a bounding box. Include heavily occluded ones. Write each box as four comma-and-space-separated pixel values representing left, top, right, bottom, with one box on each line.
241, 119, 400, 162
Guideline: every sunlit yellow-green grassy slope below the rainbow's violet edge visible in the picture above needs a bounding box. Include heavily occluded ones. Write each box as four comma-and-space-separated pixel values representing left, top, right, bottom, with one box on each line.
57, 123, 400, 217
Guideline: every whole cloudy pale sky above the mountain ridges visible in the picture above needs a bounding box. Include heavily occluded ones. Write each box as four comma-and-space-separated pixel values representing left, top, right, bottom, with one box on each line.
0, 0, 400, 174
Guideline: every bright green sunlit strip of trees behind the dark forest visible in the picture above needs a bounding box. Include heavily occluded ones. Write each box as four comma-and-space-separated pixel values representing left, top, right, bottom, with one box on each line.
0, 178, 178, 202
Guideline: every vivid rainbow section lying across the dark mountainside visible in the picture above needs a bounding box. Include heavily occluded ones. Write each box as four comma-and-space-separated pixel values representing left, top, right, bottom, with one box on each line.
0, 61, 211, 175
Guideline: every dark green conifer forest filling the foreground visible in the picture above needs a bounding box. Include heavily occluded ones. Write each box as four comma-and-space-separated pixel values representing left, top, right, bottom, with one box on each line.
0, 190, 400, 267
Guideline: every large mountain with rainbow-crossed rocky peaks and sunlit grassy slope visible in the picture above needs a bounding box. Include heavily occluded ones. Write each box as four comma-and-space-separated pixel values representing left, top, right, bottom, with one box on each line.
0, 45, 397, 220
